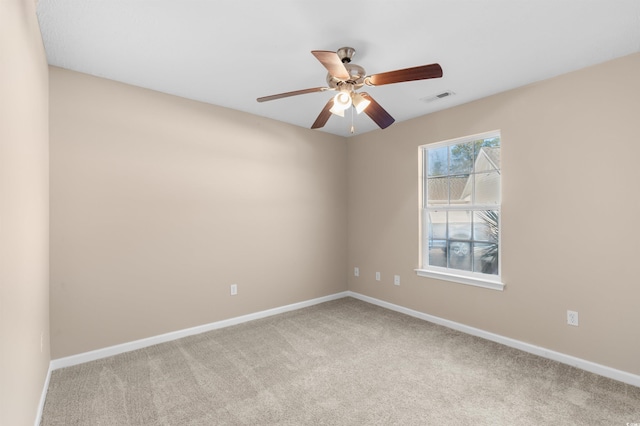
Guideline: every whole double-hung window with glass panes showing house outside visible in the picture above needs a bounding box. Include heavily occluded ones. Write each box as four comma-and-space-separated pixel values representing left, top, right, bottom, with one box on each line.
416, 131, 504, 290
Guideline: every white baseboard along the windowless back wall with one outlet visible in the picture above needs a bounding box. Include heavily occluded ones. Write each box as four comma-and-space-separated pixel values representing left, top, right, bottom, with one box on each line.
50, 291, 349, 370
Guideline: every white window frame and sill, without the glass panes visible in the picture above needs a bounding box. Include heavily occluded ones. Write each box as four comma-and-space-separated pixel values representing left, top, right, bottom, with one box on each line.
415, 130, 505, 290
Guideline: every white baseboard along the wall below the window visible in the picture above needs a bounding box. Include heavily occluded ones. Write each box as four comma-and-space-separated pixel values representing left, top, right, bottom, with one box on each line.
347, 291, 640, 387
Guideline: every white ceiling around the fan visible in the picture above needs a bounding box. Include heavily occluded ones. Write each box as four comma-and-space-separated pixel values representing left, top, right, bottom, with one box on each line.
38, 0, 640, 136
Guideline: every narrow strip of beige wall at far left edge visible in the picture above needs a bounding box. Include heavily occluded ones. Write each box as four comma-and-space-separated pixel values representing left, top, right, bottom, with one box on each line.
0, 0, 50, 426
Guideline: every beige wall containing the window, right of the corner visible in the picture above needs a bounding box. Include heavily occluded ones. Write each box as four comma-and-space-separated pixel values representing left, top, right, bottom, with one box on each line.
348, 54, 640, 374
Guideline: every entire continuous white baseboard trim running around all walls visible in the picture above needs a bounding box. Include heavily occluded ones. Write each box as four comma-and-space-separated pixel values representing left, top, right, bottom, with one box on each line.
50, 291, 640, 390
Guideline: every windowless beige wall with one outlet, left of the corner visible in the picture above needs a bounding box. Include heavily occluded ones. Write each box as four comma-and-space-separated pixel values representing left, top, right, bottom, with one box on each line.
50, 67, 347, 358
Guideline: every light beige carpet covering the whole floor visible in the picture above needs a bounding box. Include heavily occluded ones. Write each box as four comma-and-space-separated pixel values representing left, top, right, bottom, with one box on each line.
42, 298, 640, 426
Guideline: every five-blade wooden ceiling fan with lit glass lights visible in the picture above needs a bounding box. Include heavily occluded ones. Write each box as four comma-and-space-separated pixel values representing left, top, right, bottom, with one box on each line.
257, 47, 442, 131
